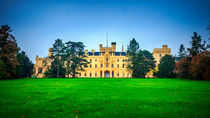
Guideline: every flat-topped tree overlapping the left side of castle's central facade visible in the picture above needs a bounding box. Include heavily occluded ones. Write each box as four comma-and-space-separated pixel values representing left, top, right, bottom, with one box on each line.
65, 41, 89, 78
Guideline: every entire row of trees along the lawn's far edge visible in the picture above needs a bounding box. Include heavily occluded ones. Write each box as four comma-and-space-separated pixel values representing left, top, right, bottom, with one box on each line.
0, 25, 210, 79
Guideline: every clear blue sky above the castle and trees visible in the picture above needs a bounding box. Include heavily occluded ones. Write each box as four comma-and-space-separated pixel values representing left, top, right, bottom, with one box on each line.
0, 0, 210, 62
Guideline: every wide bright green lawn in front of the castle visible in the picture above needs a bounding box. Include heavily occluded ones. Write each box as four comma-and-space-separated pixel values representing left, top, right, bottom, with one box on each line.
0, 78, 210, 118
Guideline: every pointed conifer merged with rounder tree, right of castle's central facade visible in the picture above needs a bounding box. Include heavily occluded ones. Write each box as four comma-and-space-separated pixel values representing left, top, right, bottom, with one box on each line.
127, 38, 155, 78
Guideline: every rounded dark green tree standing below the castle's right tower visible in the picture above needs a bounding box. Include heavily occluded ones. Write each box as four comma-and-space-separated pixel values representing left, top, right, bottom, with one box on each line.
157, 55, 175, 78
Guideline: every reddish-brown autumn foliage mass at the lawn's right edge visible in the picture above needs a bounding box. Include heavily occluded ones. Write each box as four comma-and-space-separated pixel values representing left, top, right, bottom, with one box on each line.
176, 51, 210, 80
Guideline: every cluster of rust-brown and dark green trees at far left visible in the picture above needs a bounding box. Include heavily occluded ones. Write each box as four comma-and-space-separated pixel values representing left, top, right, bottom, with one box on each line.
0, 25, 33, 79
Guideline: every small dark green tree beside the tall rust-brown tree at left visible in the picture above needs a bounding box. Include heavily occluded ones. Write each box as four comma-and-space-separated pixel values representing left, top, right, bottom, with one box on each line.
16, 51, 34, 77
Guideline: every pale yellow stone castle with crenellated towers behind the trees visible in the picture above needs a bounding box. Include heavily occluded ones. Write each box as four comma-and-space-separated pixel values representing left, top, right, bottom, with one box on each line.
34, 42, 171, 78
